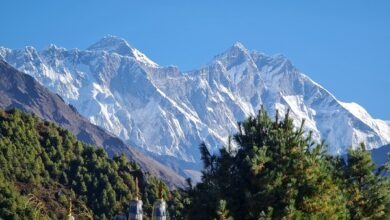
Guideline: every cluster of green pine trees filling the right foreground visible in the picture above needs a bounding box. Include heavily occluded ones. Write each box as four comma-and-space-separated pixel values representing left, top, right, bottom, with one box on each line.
182, 109, 390, 219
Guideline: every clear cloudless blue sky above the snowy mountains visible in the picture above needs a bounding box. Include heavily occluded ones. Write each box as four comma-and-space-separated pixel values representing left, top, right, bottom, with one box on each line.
0, 0, 390, 120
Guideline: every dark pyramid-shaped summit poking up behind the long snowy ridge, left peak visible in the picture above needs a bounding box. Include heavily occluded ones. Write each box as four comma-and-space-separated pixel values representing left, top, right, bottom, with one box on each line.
87, 35, 158, 67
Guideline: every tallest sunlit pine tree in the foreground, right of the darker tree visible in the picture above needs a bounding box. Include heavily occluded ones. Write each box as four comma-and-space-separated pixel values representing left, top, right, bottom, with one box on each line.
235, 109, 346, 218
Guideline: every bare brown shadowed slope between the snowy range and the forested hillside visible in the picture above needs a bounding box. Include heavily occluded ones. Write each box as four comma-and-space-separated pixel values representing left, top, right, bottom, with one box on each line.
0, 60, 184, 186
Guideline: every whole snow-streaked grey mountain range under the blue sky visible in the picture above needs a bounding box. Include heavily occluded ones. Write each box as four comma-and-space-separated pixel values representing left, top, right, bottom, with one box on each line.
0, 36, 390, 167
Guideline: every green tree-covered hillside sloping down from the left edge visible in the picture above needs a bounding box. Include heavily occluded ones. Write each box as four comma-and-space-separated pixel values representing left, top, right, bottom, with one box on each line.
0, 110, 168, 219
